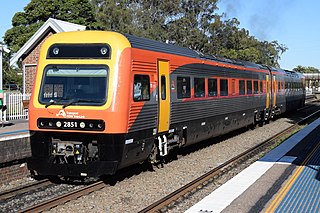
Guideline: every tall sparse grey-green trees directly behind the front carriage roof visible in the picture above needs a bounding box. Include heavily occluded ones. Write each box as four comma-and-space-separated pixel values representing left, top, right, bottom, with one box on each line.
92, 0, 217, 51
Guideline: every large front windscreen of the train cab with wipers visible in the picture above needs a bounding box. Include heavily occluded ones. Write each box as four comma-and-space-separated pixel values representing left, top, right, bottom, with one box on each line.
39, 65, 108, 107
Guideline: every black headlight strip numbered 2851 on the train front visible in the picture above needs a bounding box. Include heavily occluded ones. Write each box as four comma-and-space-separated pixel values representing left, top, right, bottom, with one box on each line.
37, 118, 105, 131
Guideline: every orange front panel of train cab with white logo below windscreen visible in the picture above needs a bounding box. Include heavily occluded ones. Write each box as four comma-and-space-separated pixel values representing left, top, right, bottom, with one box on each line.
29, 42, 131, 133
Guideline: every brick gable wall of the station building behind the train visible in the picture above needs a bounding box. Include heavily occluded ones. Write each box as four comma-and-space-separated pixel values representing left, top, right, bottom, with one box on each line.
22, 32, 54, 93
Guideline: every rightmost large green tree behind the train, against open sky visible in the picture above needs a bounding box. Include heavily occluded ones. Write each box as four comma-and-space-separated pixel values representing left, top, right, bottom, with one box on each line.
206, 16, 287, 67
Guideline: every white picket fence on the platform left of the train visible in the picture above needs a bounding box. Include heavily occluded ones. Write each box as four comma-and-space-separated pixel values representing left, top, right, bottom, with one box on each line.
0, 93, 31, 122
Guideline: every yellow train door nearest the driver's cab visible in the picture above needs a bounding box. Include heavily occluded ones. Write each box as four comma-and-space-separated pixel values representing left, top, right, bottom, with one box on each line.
158, 60, 170, 132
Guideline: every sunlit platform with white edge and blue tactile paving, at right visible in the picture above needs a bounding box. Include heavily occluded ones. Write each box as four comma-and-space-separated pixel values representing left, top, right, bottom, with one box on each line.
186, 118, 320, 213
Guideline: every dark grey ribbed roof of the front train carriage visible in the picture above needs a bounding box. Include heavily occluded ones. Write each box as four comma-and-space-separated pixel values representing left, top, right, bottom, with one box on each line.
123, 34, 268, 69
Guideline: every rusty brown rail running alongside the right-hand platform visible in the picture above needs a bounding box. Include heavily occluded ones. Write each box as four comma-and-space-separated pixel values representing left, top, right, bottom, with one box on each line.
139, 110, 320, 213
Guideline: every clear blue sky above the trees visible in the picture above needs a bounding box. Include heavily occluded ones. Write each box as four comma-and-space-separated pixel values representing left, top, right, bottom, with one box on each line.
0, 0, 320, 70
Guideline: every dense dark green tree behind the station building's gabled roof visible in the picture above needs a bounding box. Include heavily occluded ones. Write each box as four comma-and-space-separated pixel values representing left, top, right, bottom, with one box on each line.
4, 0, 99, 52
